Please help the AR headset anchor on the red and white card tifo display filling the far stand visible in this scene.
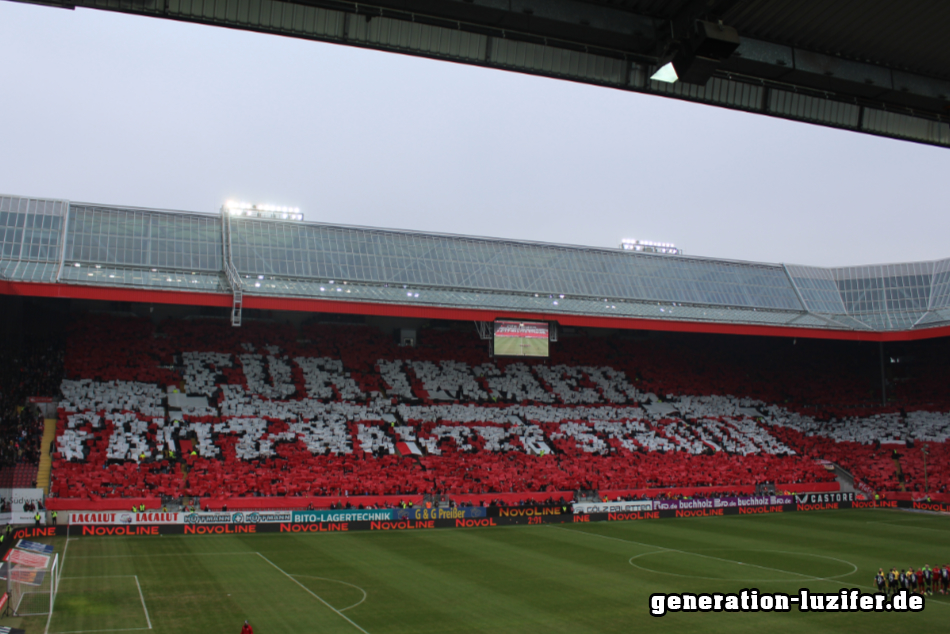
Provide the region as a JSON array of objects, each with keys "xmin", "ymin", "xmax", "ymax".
[{"xmin": 44, "ymin": 315, "xmax": 950, "ymax": 505}]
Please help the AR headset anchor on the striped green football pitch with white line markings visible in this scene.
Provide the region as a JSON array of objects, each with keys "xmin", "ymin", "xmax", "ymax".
[{"xmin": 7, "ymin": 510, "xmax": 950, "ymax": 634}]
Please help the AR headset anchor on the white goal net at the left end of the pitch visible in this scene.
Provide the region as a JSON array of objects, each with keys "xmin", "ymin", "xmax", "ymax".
[{"xmin": 0, "ymin": 548, "xmax": 60, "ymax": 616}]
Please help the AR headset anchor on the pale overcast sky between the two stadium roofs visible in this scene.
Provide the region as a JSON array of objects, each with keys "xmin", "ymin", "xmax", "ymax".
[{"xmin": 0, "ymin": 1, "xmax": 950, "ymax": 266}]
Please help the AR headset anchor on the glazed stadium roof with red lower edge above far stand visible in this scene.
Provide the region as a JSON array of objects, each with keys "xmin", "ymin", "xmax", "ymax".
[{"xmin": 0, "ymin": 196, "xmax": 950, "ymax": 340}]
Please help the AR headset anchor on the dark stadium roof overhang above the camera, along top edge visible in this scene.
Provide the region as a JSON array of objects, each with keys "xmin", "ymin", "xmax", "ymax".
[{"xmin": 13, "ymin": 0, "xmax": 950, "ymax": 147}]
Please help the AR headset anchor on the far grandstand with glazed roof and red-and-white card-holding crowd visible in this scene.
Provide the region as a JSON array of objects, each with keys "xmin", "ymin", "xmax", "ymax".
[{"xmin": 0, "ymin": 189, "xmax": 950, "ymax": 510}]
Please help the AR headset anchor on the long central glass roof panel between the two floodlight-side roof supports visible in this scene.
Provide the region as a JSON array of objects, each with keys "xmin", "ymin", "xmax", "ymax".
[{"xmin": 231, "ymin": 218, "xmax": 802, "ymax": 310}]
